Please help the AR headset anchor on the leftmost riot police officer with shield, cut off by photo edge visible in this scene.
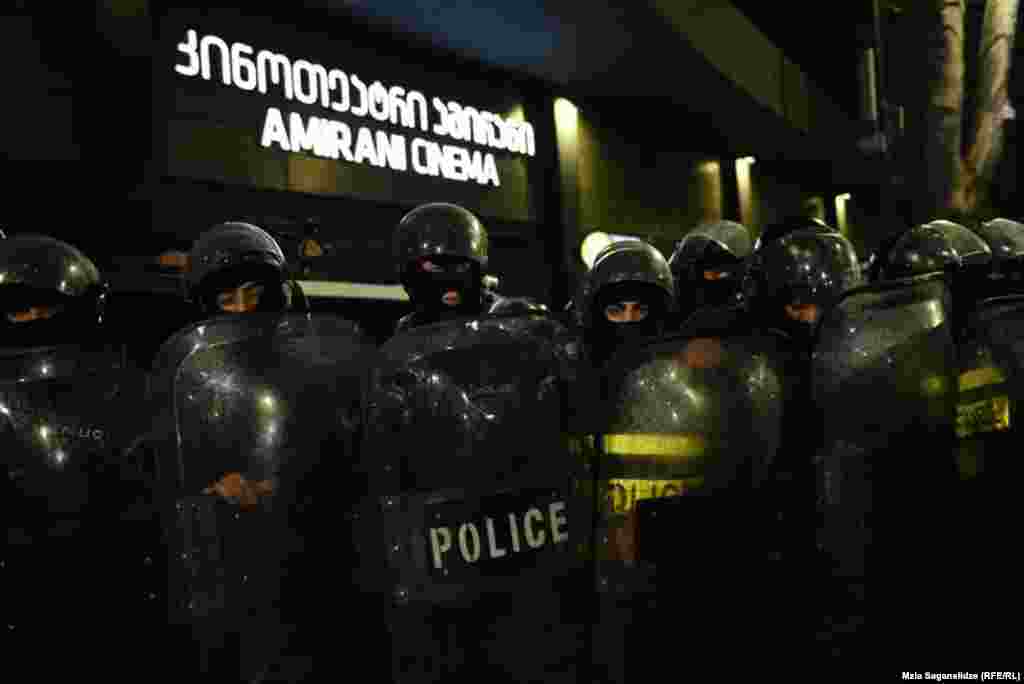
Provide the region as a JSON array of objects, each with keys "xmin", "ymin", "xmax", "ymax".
[{"xmin": 0, "ymin": 234, "xmax": 159, "ymax": 679}]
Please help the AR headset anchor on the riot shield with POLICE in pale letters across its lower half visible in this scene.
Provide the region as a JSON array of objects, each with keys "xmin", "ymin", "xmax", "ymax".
[{"xmin": 360, "ymin": 314, "xmax": 588, "ymax": 682}]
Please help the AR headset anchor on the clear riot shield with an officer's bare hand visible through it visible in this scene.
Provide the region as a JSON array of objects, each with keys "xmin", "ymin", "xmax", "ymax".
[{"xmin": 151, "ymin": 314, "xmax": 373, "ymax": 681}]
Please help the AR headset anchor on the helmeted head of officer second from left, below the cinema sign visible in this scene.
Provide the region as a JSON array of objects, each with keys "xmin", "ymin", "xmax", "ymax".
[{"xmin": 185, "ymin": 221, "xmax": 289, "ymax": 316}]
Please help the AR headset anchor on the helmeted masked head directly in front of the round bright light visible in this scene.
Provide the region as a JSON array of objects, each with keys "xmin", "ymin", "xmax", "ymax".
[{"xmin": 580, "ymin": 240, "xmax": 676, "ymax": 361}]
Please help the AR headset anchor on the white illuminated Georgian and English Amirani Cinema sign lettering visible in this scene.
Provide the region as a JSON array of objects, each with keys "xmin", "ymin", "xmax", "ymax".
[{"xmin": 174, "ymin": 29, "xmax": 536, "ymax": 187}]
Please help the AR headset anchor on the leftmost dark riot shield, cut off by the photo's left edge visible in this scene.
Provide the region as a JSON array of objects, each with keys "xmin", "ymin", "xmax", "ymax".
[{"xmin": 0, "ymin": 344, "xmax": 153, "ymax": 678}]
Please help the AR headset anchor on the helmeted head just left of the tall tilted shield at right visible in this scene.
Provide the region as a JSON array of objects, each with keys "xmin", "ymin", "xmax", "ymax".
[{"xmin": 744, "ymin": 230, "xmax": 862, "ymax": 340}]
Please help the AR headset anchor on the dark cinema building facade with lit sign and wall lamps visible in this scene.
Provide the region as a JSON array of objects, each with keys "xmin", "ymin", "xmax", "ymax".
[{"xmin": 5, "ymin": 0, "xmax": 876, "ymax": 307}]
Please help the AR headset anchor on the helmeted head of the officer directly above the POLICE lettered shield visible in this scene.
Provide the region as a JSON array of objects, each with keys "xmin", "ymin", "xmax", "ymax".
[{"xmin": 394, "ymin": 203, "xmax": 487, "ymax": 315}]
